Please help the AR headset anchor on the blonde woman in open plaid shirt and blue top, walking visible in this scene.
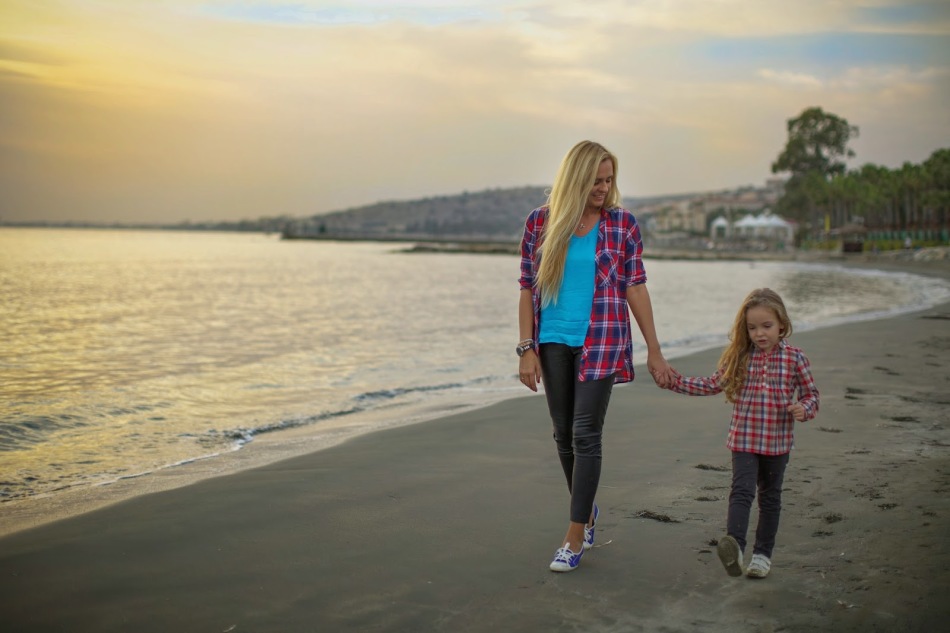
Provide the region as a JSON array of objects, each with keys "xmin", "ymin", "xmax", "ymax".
[{"xmin": 517, "ymin": 141, "xmax": 673, "ymax": 572}]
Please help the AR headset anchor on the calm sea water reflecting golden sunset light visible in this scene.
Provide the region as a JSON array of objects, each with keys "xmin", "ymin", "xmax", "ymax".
[{"xmin": 0, "ymin": 229, "xmax": 950, "ymax": 501}]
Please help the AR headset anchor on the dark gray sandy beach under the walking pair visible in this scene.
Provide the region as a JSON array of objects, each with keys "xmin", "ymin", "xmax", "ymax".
[{"xmin": 0, "ymin": 264, "xmax": 950, "ymax": 633}]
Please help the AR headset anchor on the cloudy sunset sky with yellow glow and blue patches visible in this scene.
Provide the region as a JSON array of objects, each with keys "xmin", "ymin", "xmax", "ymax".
[{"xmin": 0, "ymin": 0, "xmax": 950, "ymax": 223}]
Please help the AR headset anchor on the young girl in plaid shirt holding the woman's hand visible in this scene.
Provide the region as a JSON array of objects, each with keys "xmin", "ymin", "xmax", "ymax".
[{"xmin": 670, "ymin": 288, "xmax": 818, "ymax": 578}]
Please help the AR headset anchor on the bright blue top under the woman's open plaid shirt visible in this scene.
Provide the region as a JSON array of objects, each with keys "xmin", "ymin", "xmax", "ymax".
[{"xmin": 538, "ymin": 226, "xmax": 599, "ymax": 347}]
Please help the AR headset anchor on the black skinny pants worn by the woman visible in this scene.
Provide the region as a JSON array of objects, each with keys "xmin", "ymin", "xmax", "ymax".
[{"xmin": 540, "ymin": 343, "xmax": 614, "ymax": 524}]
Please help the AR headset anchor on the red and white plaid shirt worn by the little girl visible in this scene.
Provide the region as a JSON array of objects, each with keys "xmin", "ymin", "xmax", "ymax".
[{"xmin": 671, "ymin": 340, "xmax": 818, "ymax": 455}]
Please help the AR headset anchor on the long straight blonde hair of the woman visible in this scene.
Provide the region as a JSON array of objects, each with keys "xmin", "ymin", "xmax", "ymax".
[{"xmin": 535, "ymin": 141, "xmax": 621, "ymax": 305}]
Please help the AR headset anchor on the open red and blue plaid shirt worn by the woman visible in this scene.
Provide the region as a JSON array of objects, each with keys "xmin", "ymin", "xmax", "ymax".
[{"xmin": 519, "ymin": 207, "xmax": 647, "ymax": 383}]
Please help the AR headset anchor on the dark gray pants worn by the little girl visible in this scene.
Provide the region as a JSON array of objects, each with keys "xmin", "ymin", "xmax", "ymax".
[{"xmin": 726, "ymin": 451, "xmax": 789, "ymax": 559}]
